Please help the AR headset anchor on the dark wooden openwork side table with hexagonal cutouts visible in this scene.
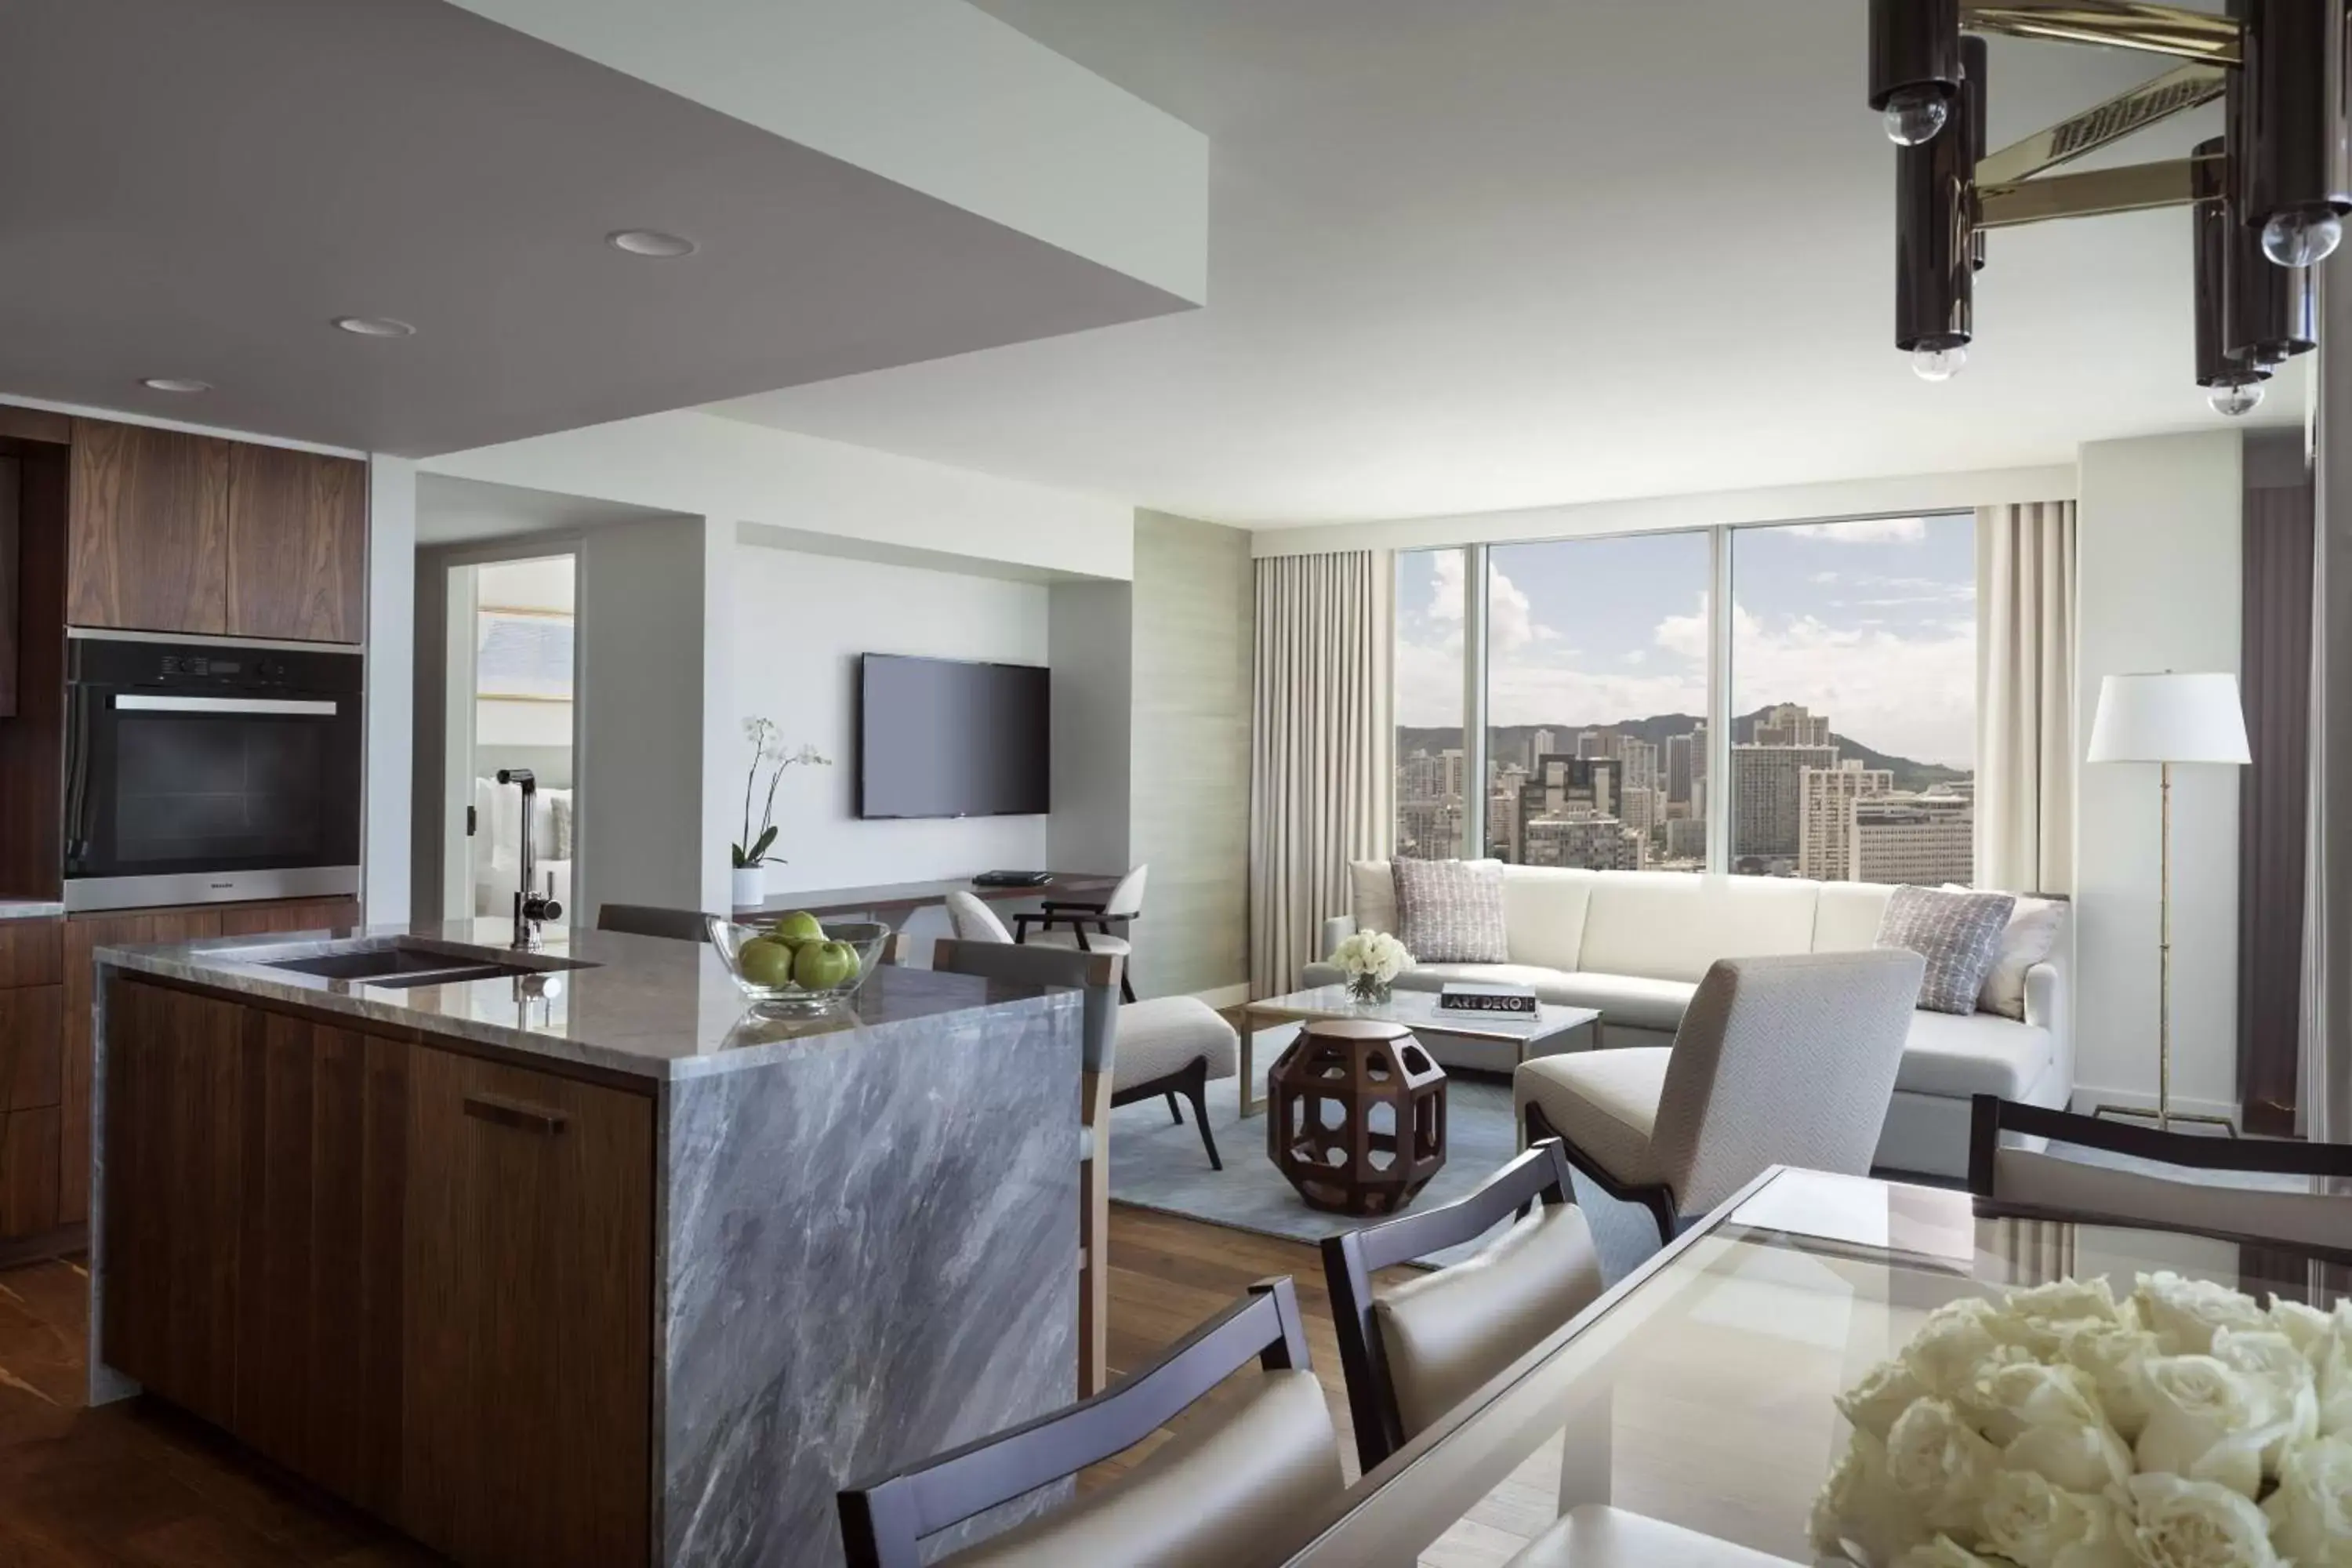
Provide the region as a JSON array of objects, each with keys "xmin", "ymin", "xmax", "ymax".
[{"xmin": 1265, "ymin": 1018, "xmax": 1446, "ymax": 1218}]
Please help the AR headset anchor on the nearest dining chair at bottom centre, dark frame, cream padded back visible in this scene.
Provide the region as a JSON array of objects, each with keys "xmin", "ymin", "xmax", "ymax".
[{"xmin": 840, "ymin": 1279, "xmax": 1345, "ymax": 1568}]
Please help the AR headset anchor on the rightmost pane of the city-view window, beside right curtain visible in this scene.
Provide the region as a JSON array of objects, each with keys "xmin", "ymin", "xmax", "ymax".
[{"xmin": 1729, "ymin": 515, "xmax": 1976, "ymax": 886}]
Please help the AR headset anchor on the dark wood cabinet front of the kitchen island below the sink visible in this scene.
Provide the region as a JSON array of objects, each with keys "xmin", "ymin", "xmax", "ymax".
[{"xmin": 101, "ymin": 975, "xmax": 654, "ymax": 1566}]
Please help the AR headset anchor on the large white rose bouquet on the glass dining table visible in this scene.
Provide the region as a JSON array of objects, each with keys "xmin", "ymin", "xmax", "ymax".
[{"xmin": 1811, "ymin": 1272, "xmax": 2352, "ymax": 1568}]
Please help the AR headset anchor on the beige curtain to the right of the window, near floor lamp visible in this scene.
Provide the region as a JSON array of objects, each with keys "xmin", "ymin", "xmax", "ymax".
[{"xmin": 1976, "ymin": 501, "xmax": 2074, "ymax": 893}]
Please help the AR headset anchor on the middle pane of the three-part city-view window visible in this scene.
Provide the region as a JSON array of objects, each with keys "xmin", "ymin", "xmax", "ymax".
[{"xmin": 1484, "ymin": 534, "xmax": 1710, "ymax": 869}]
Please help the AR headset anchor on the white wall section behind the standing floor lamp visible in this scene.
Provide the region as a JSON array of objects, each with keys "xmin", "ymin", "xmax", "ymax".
[{"xmin": 2074, "ymin": 430, "xmax": 2244, "ymax": 1112}]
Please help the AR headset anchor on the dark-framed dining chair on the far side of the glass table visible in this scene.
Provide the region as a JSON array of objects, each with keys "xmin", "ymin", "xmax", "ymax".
[{"xmin": 1969, "ymin": 1095, "xmax": 2352, "ymax": 1253}]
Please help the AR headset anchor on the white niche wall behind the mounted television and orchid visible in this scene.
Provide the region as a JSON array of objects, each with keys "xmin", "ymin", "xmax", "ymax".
[{"xmin": 729, "ymin": 543, "xmax": 1054, "ymax": 907}]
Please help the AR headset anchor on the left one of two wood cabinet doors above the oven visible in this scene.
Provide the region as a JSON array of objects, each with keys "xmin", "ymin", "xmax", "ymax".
[{"xmin": 66, "ymin": 419, "xmax": 233, "ymax": 635}]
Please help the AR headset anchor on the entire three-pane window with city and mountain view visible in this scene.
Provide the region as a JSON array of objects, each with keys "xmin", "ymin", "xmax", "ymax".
[{"xmin": 1395, "ymin": 513, "xmax": 1976, "ymax": 884}]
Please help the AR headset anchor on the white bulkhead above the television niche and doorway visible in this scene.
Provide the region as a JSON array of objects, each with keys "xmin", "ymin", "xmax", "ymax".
[{"xmin": 423, "ymin": 409, "xmax": 1134, "ymax": 579}]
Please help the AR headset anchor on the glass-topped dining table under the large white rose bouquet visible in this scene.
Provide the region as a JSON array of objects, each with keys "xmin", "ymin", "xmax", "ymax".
[{"xmin": 1291, "ymin": 1168, "xmax": 2343, "ymax": 1568}]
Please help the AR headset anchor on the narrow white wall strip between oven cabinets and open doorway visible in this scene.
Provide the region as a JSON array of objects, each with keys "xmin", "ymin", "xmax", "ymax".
[{"xmin": 360, "ymin": 456, "xmax": 416, "ymax": 926}]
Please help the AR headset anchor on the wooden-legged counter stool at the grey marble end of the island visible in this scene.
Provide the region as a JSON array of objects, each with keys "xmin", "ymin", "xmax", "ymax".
[{"xmin": 931, "ymin": 938, "xmax": 1120, "ymax": 1394}]
